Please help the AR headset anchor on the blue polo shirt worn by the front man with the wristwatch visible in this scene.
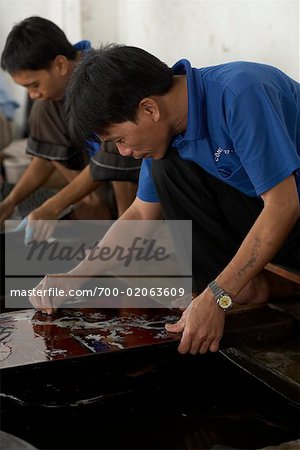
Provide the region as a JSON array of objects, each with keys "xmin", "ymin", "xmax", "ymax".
[{"xmin": 137, "ymin": 59, "xmax": 300, "ymax": 202}]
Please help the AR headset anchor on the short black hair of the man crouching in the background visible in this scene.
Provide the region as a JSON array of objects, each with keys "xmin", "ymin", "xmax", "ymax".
[{"xmin": 1, "ymin": 16, "xmax": 76, "ymax": 75}]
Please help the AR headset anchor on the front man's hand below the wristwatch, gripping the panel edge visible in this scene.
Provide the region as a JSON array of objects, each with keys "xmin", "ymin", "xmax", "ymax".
[{"xmin": 166, "ymin": 288, "xmax": 225, "ymax": 355}]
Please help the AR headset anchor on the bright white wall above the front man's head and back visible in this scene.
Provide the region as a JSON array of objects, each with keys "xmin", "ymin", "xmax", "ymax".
[{"xmin": 81, "ymin": 0, "xmax": 299, "ymax": 79}]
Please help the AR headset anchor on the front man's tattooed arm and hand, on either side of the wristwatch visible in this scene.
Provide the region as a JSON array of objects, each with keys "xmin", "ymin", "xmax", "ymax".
[{"xmin": 167, "ymin": 175, "xmax": 299, "ymax": 354}]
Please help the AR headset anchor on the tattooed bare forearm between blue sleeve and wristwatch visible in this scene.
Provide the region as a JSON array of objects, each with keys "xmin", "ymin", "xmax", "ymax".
[{"xmin": 217, "ymin": 175, "xmax": 300, "ymax": 297}]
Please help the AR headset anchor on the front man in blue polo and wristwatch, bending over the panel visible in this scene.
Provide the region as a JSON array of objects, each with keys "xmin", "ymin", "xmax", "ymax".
[{"xmin": 32, "ymin": 45, "xmax": 300, "ymax": 354}]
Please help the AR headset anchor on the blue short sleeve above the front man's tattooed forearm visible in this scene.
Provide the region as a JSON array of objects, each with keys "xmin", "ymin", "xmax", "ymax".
[{"xmin": 227, "ymin": 84, "xmax": 300, "ymax": 195}]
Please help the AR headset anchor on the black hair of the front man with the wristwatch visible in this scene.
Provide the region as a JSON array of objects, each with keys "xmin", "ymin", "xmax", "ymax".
[{"xmin": 65, "ymin": 44, "xmax": 173, "ymax": 145}]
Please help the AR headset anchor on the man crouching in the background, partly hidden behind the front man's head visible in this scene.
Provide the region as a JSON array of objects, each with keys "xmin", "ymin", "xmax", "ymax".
[{"xmin": 0, "ymin": 17, "xmax": 139, "ymax": 238}]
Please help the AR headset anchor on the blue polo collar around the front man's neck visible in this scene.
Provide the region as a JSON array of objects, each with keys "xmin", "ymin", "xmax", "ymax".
[{"xmin": 172, "ymin": 59, "xmax": 205, "ymax": 141}]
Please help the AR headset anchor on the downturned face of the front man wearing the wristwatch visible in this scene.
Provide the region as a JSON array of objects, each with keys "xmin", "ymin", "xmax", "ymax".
[{"xmin": 100, "ymin": 107, "xmax": 172, "ymax": 159}]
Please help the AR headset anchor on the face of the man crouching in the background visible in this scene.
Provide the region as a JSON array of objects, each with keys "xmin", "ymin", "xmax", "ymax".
[{"xmin": 12, "ymin": 60, "xmax": 66, "ymax": 100}]
